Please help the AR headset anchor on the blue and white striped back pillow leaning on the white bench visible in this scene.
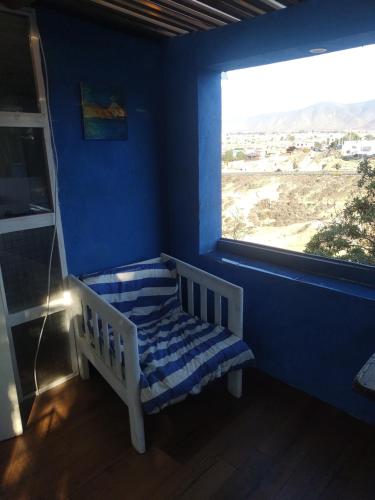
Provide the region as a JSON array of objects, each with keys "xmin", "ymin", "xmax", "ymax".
[{"xmin": 81, "ymin": 257, "xmax": 181, "ymax": 326}]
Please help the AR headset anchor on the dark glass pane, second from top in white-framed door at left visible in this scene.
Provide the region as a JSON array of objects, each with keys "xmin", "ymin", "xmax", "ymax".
[{"xmin": 0, "ymin": 127, "xmax": 52, "ymax": 219}]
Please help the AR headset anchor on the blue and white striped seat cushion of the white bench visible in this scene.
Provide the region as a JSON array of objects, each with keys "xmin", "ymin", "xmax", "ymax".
[{"xmin": 138, "ymin": 312, "xmax": 254, "ymax": 413}]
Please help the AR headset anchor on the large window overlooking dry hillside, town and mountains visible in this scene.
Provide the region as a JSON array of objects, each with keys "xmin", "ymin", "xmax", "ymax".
[{"xmin": 222, "ymin": 45, "xmax": 375, "ymax": 264}]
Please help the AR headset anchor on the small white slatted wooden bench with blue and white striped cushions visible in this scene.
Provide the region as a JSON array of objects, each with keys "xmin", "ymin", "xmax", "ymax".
[{"xmin": 69, "ymin": 254, "xmax": 254, "ymax": 453}]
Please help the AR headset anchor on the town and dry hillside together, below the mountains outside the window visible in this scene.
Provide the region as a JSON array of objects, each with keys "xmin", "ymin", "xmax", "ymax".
[{"xmin": 222, "ymin": 130, "xmax": 375, "ymax": 252}]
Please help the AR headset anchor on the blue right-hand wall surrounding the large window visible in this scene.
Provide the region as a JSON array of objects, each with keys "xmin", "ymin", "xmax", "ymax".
[{"xmin": 165, "ymin": 0, "xmax": 375, "ymax": 423}]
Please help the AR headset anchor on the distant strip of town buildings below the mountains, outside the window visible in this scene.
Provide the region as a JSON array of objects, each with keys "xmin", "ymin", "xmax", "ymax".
[{"xmin": 222, "ymin": 130, "xmax": 375, "ymax": 173}]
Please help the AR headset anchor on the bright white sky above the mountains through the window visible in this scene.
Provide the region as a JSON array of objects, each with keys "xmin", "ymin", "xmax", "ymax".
[{"xmin": 221, "ymin": 45, "xmax": 375, "ymax": 131}]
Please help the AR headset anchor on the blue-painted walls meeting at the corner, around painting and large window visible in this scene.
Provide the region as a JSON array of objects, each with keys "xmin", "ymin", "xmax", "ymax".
[{"xmin": 38, "ymin": 0, "xmax": 375, "ymax": 422}]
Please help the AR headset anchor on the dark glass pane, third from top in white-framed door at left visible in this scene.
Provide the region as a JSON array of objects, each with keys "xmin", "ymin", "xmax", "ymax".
[{"xmin": 0, "ymin": 226, "xmax": 62, "ymax": 313}]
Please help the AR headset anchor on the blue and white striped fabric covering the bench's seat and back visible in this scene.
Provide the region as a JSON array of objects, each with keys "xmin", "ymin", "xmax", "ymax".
[{"xmin": 83, "ymin": 259, "xmax": 254, "ymax": 413}]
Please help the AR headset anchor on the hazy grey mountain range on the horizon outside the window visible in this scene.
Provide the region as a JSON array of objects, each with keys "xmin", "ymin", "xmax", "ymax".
[{"xmin": 230, "ymin": 100, "xmax": 375, "ymax": 133}]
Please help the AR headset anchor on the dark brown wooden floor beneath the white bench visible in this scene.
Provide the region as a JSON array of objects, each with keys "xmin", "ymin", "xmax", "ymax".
[{"xmin": 0, "ymin": 372, "xmax": 375, "ymax": 500}]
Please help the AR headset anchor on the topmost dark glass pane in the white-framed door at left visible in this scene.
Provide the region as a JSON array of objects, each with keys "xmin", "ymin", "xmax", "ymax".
[{"xmin": 0, "ymin": 12, "xmax": 39, "ymax": 113}]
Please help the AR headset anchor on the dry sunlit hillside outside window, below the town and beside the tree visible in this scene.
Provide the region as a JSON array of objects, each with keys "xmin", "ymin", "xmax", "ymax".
[{"xmin": 222, "ymin": 173, "xmax": 359, "ymax": 252}]
